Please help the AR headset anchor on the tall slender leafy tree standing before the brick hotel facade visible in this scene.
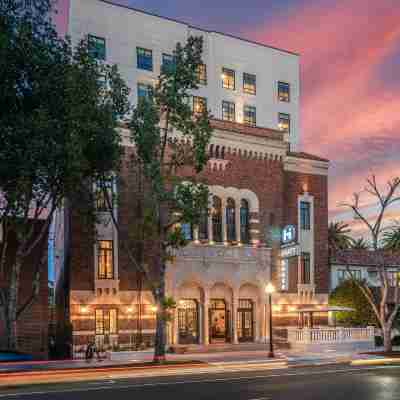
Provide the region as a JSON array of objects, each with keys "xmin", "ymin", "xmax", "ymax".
[{"xmin": 104, "ymin": 37, "xmax": 212, "ymax": 362}]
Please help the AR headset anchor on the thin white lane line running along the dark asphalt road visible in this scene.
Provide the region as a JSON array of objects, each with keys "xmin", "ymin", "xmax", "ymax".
[{"xmin": 0, "ymin": 365, "xmax": 400, "ymax": 398}]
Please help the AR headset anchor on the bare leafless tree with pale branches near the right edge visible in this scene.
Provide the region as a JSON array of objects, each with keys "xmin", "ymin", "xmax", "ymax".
[{"xmin": 343, "ymin": 175, "xmax": 400, "ymax": 352}]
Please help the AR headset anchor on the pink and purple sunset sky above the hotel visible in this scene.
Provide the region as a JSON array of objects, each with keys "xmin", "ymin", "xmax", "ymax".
[{"xmin": 57, "ymin": 0, "xmax": 400, "ymax": 219}]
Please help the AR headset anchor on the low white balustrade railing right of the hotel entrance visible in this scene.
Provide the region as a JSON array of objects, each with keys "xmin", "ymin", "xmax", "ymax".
[{"xmin": 288, "ymin": 326, "xmax": 375, "ymax": 343}]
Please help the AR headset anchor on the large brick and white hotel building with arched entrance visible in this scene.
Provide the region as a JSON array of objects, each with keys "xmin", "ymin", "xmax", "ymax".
[{"xmin": 55, "ymin": 0, "xmax": 329, "ymax": 350}]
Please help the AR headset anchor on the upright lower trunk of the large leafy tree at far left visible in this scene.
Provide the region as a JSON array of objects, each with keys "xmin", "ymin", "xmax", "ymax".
[{"xmin": 5, "ymin": 252, "xmax": 22, "ymax": 350}]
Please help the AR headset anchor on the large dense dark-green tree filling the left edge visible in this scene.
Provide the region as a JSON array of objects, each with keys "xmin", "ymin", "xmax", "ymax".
[{"xmin": 0, "ymin": 0, "xmax": 128, "ymax": 349}]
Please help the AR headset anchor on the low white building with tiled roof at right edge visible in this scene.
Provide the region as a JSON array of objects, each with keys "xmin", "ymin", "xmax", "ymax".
[{"xmin": 330, "ymin": 249, "xmax": 400, "ymax": 291}]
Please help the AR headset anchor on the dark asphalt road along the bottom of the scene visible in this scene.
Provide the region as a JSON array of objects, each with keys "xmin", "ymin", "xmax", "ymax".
[{"xmin": 0, "ymin": 365, "xmax": 400, "ymax": 400}]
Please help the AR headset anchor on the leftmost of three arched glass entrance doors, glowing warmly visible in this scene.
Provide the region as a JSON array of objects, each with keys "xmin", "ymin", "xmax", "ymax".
[{"xmin": 178, "ymin": 300, "xmax": 199, "ymax": 344}]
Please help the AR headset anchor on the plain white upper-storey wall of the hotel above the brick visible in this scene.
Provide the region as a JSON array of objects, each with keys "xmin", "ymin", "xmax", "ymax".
[{"xmin": 68, "ymin": 0, "xmax": 300, "ymax": 150}]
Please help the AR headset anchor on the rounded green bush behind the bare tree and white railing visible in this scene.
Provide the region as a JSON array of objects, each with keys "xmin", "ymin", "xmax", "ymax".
[{"xmin": 329, "ymin": 279, "xmax": 378, "ymax": 326}]
